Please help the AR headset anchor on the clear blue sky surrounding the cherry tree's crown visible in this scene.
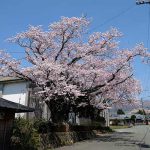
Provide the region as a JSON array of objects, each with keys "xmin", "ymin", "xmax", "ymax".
[{"xmin": 0, "ymin": 0, "xmax": 150, "ymax": 99}]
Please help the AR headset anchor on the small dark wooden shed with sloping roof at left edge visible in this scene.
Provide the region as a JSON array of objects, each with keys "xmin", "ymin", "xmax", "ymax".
[{"xmin": 0, "ymin": 98, "xmax": 34, "ymax": 150}]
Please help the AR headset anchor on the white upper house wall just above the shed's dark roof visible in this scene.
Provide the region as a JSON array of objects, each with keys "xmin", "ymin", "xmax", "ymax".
[{"xmin": 2, "ymin": 82, "xmax": 27, "ymax": 105}]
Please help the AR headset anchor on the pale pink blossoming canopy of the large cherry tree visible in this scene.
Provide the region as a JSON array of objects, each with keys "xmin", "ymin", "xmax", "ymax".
[{"xmin": 0, "ymin": 17, "xmax": 149, "ymax": 122}]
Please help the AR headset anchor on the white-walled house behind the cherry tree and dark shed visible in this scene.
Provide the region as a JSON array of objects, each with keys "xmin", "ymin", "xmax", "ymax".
[{"xmin": 0, "ymin": 77, "xmax": 50, "ymax": 119}]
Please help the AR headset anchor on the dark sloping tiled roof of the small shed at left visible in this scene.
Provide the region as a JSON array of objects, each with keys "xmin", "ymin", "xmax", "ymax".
[{"xmin": 0, "ymin": 98, "xmax": 34, "ymax": 113}]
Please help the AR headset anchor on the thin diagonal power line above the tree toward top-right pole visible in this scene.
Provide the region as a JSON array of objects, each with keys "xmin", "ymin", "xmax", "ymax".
[{"xmin": 89, "ymin": 5, "xmax": 135, "ymax": 32}]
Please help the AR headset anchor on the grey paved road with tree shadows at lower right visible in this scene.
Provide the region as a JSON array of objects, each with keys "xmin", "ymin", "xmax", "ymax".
[{"xmin": 55, "ymin": 125, "xmax": 150, "ymax": 150}]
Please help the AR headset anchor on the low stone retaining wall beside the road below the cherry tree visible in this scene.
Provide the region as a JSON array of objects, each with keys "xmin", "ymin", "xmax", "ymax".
[{"xmin": 39, "ymin": 131, "xmax": 96, "ymax": 150}]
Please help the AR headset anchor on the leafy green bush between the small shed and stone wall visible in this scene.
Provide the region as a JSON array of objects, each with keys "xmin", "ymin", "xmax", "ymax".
[{"xmin": 11, "ymin": 118, "xmax": 39, "ymax": 150}]
